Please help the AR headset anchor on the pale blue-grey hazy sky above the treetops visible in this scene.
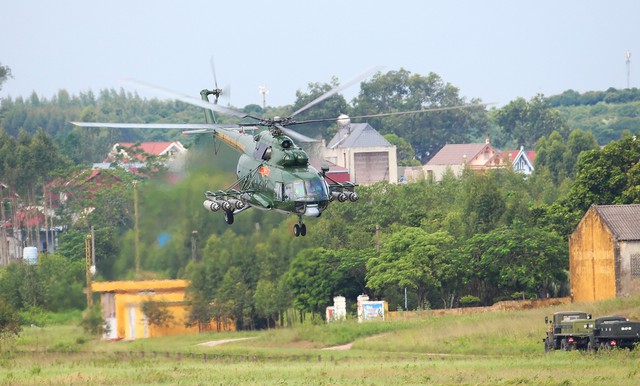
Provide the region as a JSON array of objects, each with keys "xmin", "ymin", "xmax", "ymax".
[{"xmin": 0, "ymin": 0, "xmax": 640, "ymax": 107}]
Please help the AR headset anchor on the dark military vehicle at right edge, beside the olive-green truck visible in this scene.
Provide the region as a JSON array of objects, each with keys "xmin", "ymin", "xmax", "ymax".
[{"xmin": 588, "ymin": 316, "xmax": 640, "ymax": 351}]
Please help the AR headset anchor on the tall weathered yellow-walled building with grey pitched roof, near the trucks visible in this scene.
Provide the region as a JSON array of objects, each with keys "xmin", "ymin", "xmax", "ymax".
[{"xmin": 569, "ymin": 204, "xmax": 640, "ymax": 301}]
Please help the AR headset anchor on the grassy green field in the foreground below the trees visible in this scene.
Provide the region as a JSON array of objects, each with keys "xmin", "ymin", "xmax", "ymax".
[{"xmin": 0, "ymin": 297, "xmax": 640, "ymax": 385}]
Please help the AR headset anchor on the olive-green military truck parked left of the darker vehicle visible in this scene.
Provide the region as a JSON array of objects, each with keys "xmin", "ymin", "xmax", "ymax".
[{"xmin": 542, "ymin": 311, "xmax": 593, "ymax": 351}]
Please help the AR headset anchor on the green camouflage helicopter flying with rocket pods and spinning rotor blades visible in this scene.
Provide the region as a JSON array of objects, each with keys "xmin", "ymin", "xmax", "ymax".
[{"xmin": 71, "ymin": 67, "xmax": 484, "ymax": 237}]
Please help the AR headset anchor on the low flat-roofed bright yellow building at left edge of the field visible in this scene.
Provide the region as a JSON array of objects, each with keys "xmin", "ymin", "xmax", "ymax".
[{"xmin": 91, "ymin": 280, "xmax": 235, "ymax": 340}]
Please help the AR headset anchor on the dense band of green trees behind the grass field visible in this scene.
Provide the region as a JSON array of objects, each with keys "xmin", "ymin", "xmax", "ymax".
[{"xmin": 0, "ymin": 64, "xmax": 640, "ymax": 329}]
